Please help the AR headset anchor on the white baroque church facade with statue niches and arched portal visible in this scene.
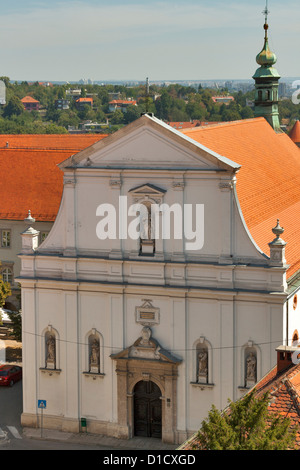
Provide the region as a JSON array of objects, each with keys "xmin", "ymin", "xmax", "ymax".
[{"xmin": 18, "ymin": 114, "xmax": 300, "ymax": 443}]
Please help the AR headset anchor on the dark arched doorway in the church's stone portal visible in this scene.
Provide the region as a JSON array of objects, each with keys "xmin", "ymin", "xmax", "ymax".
[{"xmin": 134, "ymin": 380, "xmax": 162, "ymax": 438}]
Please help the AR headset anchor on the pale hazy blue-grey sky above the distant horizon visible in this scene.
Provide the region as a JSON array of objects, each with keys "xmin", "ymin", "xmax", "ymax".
[{"xmin": 0, "ymin": 0, "xmax": 300, "ymax": 83}]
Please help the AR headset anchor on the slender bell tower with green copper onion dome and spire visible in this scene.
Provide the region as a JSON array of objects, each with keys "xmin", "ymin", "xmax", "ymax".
[{"xmin": 253, "ymin": 2, "xmax": 282, "ymax": 132}]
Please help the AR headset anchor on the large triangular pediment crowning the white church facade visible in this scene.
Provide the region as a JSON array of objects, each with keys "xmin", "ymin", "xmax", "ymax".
[{"xmin": 60, "ymin": 115, "xmax": 239, "ymax": 171}]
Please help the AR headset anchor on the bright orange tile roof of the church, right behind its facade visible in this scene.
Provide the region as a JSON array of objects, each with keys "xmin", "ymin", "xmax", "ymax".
[{"xmin": 182, "ymin": 118, "xmax": 300, "ymax": 277}]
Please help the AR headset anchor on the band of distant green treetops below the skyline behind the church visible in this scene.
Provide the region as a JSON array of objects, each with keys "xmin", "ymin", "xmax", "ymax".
[{"xmin": 0, "ymin": 77, "xmax": 300, "ymax": 134}]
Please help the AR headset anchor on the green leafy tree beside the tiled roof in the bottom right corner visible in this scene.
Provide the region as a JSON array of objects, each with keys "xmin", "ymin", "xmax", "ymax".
[{"xmin": 198, "ymin": 389, "xmax": 296, "ymax": 450}]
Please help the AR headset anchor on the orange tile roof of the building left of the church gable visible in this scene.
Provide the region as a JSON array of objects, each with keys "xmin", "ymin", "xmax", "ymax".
[{"xmin": 0, "ymin": 134, "xmax": 105, "ymax": 222}]
